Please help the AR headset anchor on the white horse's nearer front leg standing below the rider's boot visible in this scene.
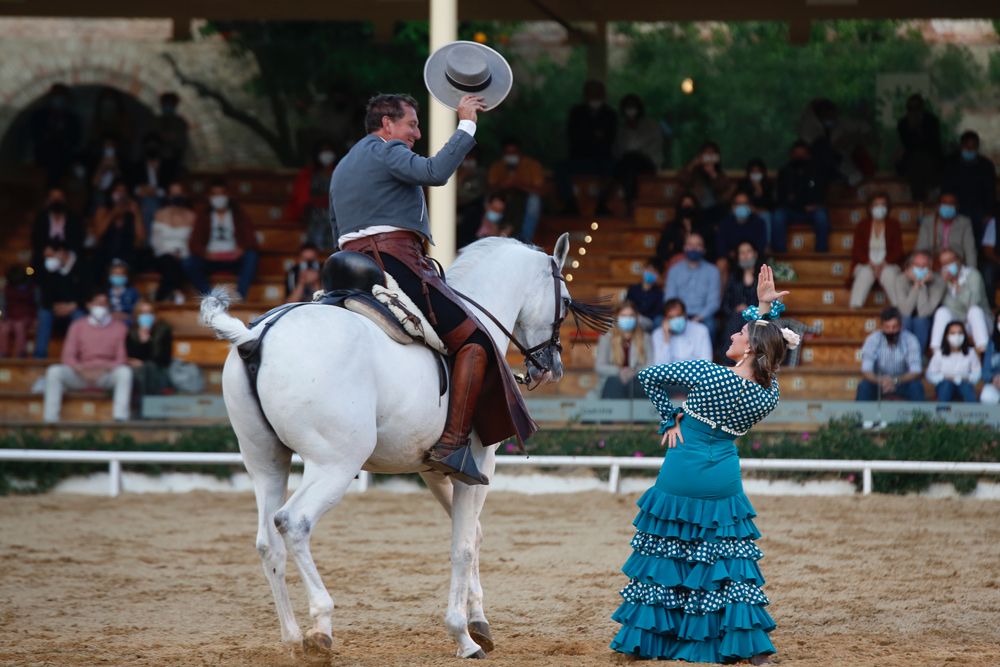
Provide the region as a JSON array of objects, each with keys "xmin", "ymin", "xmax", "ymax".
[{"xmin": 445, "ymin": 442, "xmax": 494, "ymax": 658}]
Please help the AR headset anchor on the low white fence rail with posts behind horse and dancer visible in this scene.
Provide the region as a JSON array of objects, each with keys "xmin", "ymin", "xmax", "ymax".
[{"xmin": 0, "ymin": 449, "xmax": 1000, "ymax": 497}]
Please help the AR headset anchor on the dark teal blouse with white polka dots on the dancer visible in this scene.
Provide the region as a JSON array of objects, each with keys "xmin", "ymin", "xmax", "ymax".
[{"xmin": 637, "ymin": 359, "xmax": 779, "ymax": 435}]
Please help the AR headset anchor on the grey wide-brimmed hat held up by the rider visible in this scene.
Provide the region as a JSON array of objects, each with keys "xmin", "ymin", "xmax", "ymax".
[{"xmin": 424, "ymin": 41, "xmax": 514, "ymax": 109}]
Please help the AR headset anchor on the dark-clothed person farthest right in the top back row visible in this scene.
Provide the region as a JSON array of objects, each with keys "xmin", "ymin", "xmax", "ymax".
[{"xmin": 896, "ymin": 93, "xmax": 944, "ymax": 202}]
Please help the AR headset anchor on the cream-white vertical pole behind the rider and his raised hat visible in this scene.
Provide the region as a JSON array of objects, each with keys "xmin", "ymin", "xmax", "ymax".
[{"xmin": 427, "ymin": 0, "xmax": 458, "ymax": 267}]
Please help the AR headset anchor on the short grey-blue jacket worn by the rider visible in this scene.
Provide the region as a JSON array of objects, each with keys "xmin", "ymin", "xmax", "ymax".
[{"xmin": 330, "ymin": 130, "xmax": 476, "ymax": 243}]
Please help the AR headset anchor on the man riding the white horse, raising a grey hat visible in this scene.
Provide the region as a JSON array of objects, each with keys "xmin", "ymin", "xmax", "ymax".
[{"xmin": 330, "ymin": 42, "xmax": 537, "ymax": 484}]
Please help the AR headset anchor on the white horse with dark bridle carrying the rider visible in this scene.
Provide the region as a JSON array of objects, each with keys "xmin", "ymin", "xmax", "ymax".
[{"xmin": 201, "ymin": 234, "xmax": 576, "ymax": 658}]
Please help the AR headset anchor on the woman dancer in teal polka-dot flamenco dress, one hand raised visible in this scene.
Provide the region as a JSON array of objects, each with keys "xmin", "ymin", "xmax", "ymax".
[{"xmin": 611, "ymin": 265, "xmax": 799, "ymax": 665}]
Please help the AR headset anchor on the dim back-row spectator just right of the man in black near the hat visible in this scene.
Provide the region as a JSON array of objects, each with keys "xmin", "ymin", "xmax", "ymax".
[{"xmin": 615, "ymin": 93, "xmax": 663, "ymax": 218}]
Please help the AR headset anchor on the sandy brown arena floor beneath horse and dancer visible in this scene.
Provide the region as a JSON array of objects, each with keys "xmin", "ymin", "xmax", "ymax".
[{"xmin": 0, "ymin": 491, "xmax": 1000, "ymax": 667}]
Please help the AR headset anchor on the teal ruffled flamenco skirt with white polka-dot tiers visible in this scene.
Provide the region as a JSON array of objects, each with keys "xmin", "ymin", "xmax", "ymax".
[{"xmin": 611, "ymin": 416, "xmax": 775, "ymax": 663}]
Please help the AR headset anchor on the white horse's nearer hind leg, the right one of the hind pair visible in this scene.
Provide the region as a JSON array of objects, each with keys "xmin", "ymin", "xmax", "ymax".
[{"xmin": 274, "ymin": 457, "xmax": 364, "ymax": 655}]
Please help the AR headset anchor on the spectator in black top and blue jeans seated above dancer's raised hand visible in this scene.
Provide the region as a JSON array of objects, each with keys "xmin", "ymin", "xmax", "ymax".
[{"xmin": 771, "ymin": 141, "xmax": 830, "ymax": 253}]
